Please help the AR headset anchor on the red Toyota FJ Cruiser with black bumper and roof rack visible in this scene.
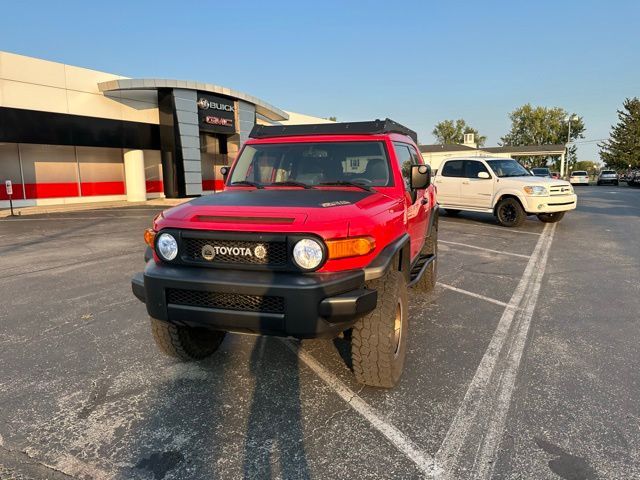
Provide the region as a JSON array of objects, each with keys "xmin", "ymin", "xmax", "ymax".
[{"xmin": 132, "ymin": 119, "xmax": 438, "ymax": 387}]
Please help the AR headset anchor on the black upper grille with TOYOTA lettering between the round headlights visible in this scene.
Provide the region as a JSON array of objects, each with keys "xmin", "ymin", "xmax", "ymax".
[{"xmin": 182, "ymin": 238, "xmax": 287, "ymax": 266}]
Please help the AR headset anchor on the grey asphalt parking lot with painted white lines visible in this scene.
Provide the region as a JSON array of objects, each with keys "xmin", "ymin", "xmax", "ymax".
[{"xmin": 0, "ymin": 186, "xmax": 640, "ymax": 479}]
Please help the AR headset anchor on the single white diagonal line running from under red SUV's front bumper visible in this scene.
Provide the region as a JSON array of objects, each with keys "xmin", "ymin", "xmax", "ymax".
[{"xmin": 282, "ymin": 340, "xmax": 440, "ymax": 478}]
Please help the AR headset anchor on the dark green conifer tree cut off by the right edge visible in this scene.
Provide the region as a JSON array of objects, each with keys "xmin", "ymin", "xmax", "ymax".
[{"xmin": 598, "ymin": 97, "xmax": 640, "ymax": 170}]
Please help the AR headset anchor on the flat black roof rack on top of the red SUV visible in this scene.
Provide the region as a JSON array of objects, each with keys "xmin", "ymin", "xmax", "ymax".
[{"xmin": 249, "ymin": 118, "xmax": 418, "ymax": 143}]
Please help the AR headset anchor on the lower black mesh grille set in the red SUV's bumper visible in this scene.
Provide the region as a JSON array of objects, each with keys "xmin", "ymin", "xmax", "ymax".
[{"xmin": 167, "ymin": 288, "xmax": 284, "ymax": 313}]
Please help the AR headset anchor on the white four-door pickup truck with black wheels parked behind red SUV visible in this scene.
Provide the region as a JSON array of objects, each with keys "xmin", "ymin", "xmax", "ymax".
[{"xmin": 434, "ymin": 157, "xmax": 577, "ymax": 227}]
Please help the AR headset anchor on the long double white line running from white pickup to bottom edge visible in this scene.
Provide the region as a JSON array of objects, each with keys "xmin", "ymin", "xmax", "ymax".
[{"xmin": 435, "ymin": 223, "xmax": 557, "ymax": 479}]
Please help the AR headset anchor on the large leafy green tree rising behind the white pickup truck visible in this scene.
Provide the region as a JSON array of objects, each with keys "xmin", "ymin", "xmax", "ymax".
[{"xmin": 501, "ymin": 103, "xmax": 585, "ymax": 169}]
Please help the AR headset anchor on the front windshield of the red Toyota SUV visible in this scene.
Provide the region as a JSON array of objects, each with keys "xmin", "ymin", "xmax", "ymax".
[{"xmin": 227, "ymin": 142, "xmax": 392, "ymax": 187}]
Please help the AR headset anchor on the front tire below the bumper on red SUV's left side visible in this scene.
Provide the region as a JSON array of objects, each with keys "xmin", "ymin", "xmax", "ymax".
[{"xmin": 151, "ymin": 318, "xmax": 226, "ymax": 362}]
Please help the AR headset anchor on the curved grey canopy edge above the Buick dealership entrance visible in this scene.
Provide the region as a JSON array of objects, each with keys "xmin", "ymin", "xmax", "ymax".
[{"xmin": 98, "ymin": 78, "xmax": 289, "ymax": 121}]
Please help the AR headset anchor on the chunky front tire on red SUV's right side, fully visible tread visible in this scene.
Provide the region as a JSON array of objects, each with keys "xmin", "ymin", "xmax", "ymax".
[{"xmin": 351, "ymin": 270, "xmax": 409, "ymax": 388}]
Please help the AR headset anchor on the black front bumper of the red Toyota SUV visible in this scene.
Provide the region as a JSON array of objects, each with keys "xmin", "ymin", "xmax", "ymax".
[{"xmin": 131, "ymin": 260, "xmax": 377, "ymax": 338}]
